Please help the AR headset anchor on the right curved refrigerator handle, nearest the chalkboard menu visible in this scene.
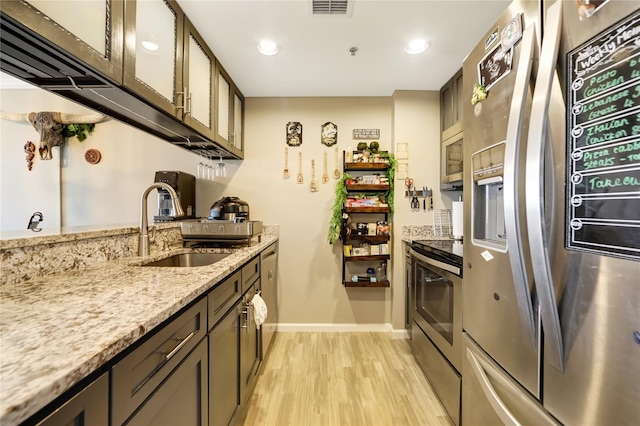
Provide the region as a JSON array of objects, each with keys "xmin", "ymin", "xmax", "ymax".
[{"xmin": 525, "ymin": 1, "xmax": 564, "ymax": 371}]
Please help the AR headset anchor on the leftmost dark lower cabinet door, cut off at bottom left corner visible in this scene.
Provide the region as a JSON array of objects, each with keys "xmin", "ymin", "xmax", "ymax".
[{"xmin": 38, "ymin": 373, "xmax": 109, "ymax": 426}]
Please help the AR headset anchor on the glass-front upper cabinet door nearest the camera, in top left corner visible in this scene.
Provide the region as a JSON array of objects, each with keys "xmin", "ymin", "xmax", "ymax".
[{"xmin": 0, "ymin": 0, "xmax": 124, "ymax": 84}]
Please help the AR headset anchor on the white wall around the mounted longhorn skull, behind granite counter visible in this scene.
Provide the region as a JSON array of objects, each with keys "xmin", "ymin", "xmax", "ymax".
[{"xmin": 0, "ymin": 89, "xmax": 225, "ymax": 231}]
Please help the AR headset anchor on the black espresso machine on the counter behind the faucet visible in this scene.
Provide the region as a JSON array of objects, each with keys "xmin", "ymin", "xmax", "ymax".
[{"xmin": 153, "ymin": 171, "xmax": 196, "ymax": 222}]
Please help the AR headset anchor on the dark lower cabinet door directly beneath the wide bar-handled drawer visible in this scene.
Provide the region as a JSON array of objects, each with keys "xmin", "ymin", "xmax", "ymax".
[{"xmin": 127, "ymin": 339, "xmax": 209, "ymax": 426}]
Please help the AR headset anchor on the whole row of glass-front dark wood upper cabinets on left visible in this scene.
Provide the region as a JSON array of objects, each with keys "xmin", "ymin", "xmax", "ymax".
[{"xmin": 0, "ymin": 0, "xmax": 244, "ymax": 159}]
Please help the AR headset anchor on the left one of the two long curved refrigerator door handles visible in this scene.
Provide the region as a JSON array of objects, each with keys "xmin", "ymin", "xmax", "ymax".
[{"xmin": 503, "ymin": 21, "xmax": 538, "ymax": 349}]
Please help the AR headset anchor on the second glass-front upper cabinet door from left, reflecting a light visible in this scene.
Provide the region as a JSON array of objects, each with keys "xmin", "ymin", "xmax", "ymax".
[{"xmin": 124, "ymin": 0, "xmax": 186, "ymax": 119}]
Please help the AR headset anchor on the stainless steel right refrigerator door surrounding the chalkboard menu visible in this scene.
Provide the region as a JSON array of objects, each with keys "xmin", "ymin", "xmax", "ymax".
[{"xmin": 536, "ymin": 0, "xmax": 640, "ymax": 425}]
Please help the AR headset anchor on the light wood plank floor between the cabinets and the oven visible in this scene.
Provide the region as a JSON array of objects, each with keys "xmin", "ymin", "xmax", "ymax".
[{"xmin": 239, "ymin": 332, "xmax": 452, "ymax": 426}]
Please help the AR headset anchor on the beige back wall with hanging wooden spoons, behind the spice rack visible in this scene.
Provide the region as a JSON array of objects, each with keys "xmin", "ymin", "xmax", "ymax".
[{"xmin": 239, "ymin": 98, "xmax": 392, "ymax": 323}]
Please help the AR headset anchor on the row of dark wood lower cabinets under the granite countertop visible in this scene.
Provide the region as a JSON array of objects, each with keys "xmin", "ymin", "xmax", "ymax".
[{"xmin": 27, "ymin": 250, "xmax": 277, "ymax": 426}]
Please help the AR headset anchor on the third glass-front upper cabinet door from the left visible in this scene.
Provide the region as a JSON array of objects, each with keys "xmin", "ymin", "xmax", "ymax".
[{"xmin": 183, "ymin": 18, "xmax": 215, "ymax": 140}]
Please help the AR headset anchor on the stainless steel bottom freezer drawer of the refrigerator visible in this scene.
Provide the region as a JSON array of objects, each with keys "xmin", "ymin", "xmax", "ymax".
[{"xmin": 462, "ymin": 334, "xmax": 559, "ymax": 426}]
